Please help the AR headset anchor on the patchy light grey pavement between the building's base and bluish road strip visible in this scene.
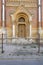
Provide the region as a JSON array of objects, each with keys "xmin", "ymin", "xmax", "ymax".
[{"xmin": 0, "ymin": 44, "xmax": 43, "ymax": 59}]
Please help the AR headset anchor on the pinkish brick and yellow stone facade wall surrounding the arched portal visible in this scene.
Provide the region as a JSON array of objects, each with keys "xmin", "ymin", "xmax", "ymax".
[{"xmin": 0, "ymin": 0, "xmax": 43, "ymax": 37}]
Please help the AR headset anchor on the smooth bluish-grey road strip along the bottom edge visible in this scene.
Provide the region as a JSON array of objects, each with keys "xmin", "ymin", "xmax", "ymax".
[{"xmin": 0, "ymin": 59, "xmax": 43, "ymax": 65}]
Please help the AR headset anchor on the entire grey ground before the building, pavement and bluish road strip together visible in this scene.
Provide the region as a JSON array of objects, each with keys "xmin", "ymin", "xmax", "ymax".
[{"xmin": 0, "ymin": 44, "xmax": 43, "ymax": 65}]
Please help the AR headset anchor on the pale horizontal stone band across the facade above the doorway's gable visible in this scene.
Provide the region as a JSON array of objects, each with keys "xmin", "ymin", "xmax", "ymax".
[{"xmin": 6, "ymin": 2, "xmax": 37, "ymax": 7}]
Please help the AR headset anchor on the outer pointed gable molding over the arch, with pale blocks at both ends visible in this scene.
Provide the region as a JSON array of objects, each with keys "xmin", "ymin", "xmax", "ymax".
[{"xmin": 10, "ymin": 5, "xmax": 32, "ymax": 22}]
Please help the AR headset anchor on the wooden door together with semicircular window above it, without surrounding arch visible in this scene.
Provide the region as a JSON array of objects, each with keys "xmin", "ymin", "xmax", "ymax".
[{"xmin": 18, "ymin": 16, "xmax": 26, "ymax": 38}]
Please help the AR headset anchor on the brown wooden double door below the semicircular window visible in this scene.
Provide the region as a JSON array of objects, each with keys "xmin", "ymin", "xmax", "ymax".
[{"xmin": 18, "ymin": 24, "xmax": 26, "ymax": 38}]
